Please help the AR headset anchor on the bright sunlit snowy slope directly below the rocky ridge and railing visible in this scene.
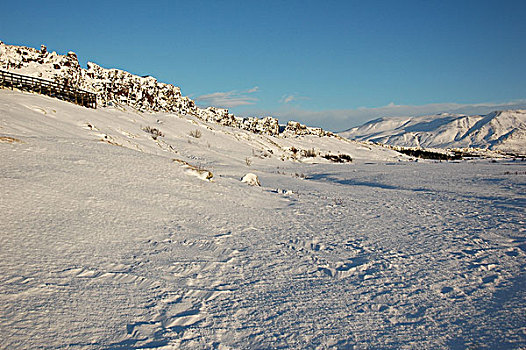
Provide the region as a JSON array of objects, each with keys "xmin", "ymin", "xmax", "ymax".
[{"xmin": 0, "ymin": 90, "xmax": 405, "ymax": 169}]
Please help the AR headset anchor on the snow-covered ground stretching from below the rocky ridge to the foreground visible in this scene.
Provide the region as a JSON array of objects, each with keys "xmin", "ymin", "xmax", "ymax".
[{"xmin": 0, "ymin": 90, "xmax": 526, "ymax": 349}]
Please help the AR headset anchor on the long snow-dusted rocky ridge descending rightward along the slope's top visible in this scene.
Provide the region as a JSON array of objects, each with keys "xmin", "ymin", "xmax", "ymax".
[{"xmin": 0, "ymin": 41, "xmax": 335, "ymax": 137}]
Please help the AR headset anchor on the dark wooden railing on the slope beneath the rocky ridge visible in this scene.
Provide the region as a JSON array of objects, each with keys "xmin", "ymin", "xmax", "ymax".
[{"xmin": 0, "ymin": 70, "xmax": 97, "ymax": 108}]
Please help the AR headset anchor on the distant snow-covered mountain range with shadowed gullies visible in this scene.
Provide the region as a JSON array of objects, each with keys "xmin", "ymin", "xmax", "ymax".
[{"xmin": 339, "ymin": 110, "xmax": 526, "ymax": 154}]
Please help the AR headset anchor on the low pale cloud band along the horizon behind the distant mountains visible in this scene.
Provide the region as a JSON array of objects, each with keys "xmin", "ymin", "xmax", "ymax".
[{"xmin": 266, "ymin": 99, "xmax": 526, "ymax": 131}]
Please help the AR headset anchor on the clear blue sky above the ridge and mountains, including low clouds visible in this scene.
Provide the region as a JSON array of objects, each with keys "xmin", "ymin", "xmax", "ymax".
[{"xmin": 0, "ymin": 0, "xmax": 526, "ymax": 130}]
